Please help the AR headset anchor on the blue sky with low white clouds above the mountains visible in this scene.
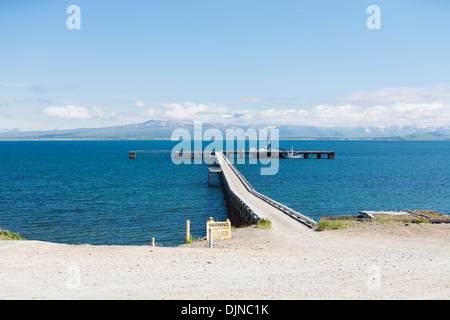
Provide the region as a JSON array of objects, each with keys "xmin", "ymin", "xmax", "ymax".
[{"xmin": 0, "ymin": 0, "xmax": 450, "ymax": 131}]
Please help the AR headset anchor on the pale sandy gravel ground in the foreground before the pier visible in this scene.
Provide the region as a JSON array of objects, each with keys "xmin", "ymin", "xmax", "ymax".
[{"xmin": 0, "ymin": 219, "xmax": 450, "ymax": 300}]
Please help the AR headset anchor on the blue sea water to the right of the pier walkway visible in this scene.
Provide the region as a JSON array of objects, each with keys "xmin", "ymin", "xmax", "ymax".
[{"xmin": 236, "ymin": 141, "xmax": 450, "ymax": 221}]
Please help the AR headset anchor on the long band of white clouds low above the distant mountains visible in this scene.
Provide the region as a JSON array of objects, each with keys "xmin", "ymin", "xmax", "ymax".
[{"xmin": 42, "ymin": 84, "xmax": 450, "ymax": 126}]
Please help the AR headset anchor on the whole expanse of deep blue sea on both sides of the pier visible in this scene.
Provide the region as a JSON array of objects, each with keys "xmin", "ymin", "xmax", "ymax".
[{"xmin": 0, "ymin": 140, "xmax": 450, "ymax": 245}]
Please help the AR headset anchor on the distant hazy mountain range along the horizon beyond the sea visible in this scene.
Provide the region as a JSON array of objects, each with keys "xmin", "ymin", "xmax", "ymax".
[{"xmin": 0, "ymin": 120, "xmax": 450, "ymax": 140}]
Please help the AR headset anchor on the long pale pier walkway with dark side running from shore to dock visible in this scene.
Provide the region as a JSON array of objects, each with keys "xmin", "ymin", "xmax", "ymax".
[{"xmin": 210, "ymin": 152, "xmax": 316, "ymax": 228}]
